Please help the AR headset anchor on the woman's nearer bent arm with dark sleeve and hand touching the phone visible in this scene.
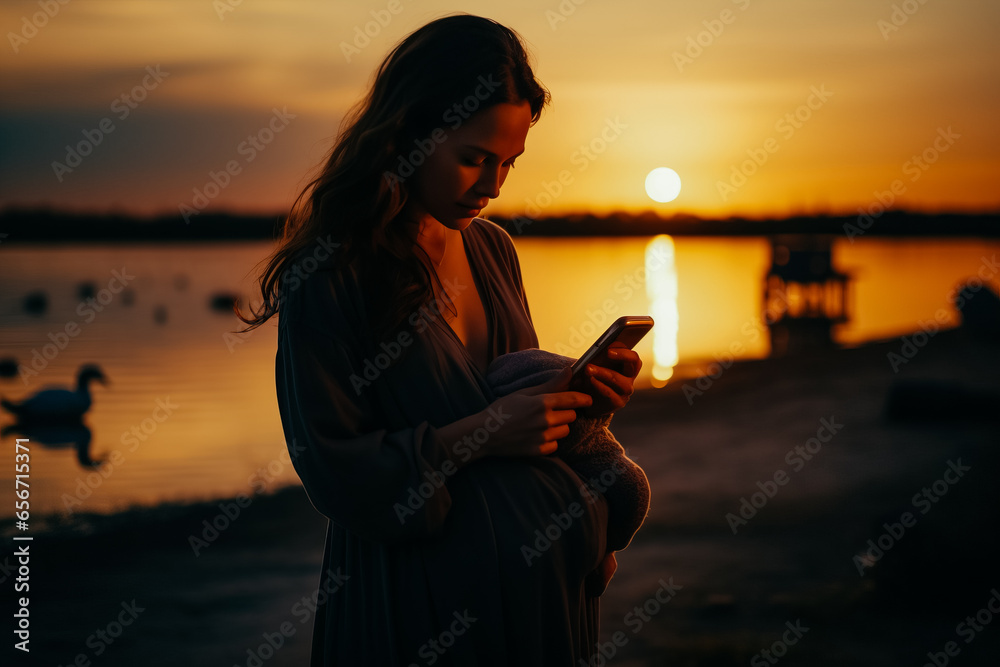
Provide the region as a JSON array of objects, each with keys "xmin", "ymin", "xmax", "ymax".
[{"xmin": 275, "ymin": 319, "xmax": 591, "ymax": 542}]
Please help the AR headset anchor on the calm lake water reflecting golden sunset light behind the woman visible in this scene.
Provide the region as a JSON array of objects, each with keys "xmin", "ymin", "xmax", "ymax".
[{"xmin": 0, "ymin": 237, "xmax": 1000, "ymax": 517}]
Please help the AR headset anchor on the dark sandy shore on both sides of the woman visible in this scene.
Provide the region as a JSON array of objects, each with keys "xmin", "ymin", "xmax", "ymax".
[{"xmin": 9, "ymin": 331, "xmax": 1000, "ymax": 667}]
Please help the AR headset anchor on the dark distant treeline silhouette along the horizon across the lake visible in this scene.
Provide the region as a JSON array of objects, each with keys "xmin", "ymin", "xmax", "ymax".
[{"xmin": 0, "ymin": 208, "xmax": 1000, "ymax": 244}]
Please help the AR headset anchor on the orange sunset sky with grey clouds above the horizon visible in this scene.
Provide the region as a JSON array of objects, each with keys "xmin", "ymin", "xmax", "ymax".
[{"xmin": 0, "ymin": 0, "xmax": 1000, "ymax": 216}]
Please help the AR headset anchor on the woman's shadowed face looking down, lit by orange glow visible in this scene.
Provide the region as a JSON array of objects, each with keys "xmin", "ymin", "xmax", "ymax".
[{"xmin": 408, "ymin": 101, "xmax": 531, "ymax": 230}]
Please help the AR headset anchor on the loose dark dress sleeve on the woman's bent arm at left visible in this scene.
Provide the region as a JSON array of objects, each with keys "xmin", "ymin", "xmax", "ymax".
[{"xmin": 275, "ymin": 276, "xmax": 451, "ymax": 542}]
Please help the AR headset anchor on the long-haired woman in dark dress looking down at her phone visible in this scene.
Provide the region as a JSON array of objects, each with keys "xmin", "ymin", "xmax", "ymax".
[{"xmin": 234, "ymin": 15, "xmax": 640, "ymax": 667}]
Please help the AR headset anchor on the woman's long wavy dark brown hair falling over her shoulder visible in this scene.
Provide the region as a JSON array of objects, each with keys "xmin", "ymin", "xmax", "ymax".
[{"xmin": 234, "ymin": 14, "xmax": 550, "ymax": 348}]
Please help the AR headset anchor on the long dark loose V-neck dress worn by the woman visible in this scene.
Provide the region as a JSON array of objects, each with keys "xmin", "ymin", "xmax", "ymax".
[{"xmin": 275, "ymin": 218, "xmax": 608, "ymax": 667}]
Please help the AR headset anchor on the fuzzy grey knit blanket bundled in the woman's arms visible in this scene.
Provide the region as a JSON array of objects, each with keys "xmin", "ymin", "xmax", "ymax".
[{"xmin": 486, "ymin": 348, "xmax": 649, "ymax": 551}]
